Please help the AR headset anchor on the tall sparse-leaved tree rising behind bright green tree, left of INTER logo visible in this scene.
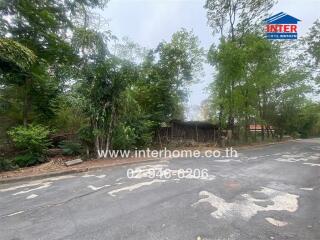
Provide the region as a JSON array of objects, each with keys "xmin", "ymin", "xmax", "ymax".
[{"xmin": 204, "ymin": 0, "xmax": 274, "ymax": 141}]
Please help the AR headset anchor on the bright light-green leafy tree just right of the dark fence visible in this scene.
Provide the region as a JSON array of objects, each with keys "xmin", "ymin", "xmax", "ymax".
[{"xmin": 209, "ymin": 34, "xmax": 279, "ymax": 141}]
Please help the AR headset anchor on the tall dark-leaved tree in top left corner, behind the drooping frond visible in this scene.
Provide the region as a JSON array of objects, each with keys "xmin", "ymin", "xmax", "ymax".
[{"xmin": 0, "ymin": 0, "xmax": 105, "ymax": 125}]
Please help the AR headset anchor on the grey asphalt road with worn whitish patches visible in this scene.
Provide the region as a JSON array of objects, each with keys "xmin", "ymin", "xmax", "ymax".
[{"xmin": 0, "ymin": 139, "xmax": 320, "ymax": 240}]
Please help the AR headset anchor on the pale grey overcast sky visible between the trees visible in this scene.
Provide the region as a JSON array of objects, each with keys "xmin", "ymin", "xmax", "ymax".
[{"xmin": 102, "ymin": 0, "xmax": 320, "ymax": 119}]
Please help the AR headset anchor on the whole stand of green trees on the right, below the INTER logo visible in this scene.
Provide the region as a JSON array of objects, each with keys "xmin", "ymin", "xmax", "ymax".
[{"xmin": 205, "ymin": 0, "xmax": 320, "ymax": 141}]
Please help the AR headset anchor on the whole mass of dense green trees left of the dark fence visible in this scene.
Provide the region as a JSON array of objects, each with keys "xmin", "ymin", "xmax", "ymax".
[{"xmin": 0, "ymin": 0, "xmax": 204, "ymax": 167}]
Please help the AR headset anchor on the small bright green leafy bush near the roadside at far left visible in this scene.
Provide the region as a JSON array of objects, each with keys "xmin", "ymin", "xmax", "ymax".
[{"xmin": 8, "ymin": 125, "xmax": 50, "ymax": 167}]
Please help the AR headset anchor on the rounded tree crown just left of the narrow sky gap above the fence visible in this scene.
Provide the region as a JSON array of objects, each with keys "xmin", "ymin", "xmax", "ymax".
[{"xmin": 138, "ymin": 29, "xmax": 204, "ymax": 123}]
